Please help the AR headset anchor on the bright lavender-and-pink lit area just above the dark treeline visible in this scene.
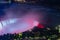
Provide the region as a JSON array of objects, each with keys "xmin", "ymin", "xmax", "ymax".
[{"xmin": 0, "ymin": 14, "xmax": 39, "ymax": 35}]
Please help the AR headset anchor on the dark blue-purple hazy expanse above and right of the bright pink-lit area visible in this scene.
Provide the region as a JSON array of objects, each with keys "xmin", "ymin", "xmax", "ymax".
[{"xmin": 0, "ymin": 0, "xmax": 60, "ymax": 33}]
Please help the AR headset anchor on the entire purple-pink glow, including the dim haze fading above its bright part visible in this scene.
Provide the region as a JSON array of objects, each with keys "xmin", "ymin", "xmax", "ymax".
[{"xmin": 0, "ymin": 5, "xmax": 45, "ymax": 35}]
